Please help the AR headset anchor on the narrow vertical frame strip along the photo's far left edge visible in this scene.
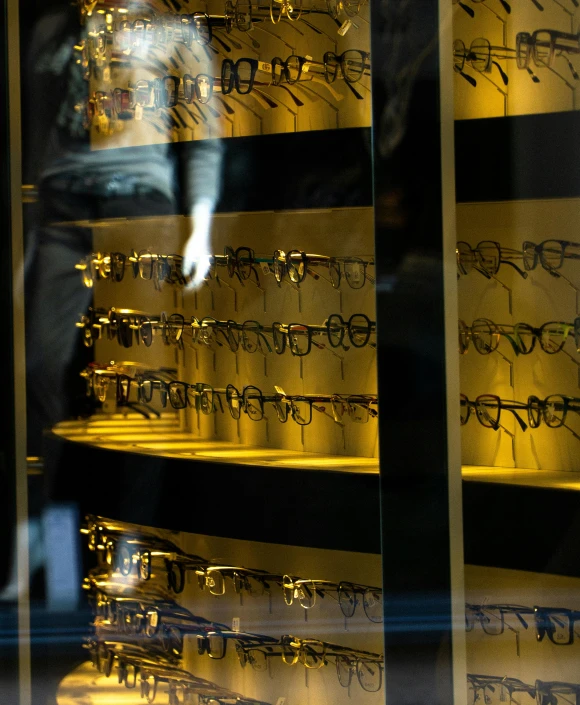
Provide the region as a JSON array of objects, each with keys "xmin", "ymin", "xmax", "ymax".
[{"xmin": 0, "ymin": 0, "xmax": 31, "ymax": 705}]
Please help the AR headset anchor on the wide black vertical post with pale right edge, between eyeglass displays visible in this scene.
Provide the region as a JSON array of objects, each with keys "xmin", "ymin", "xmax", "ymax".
[{"xmin": 371, "ymin": 0, "xmax": 466, "ymax": 705}]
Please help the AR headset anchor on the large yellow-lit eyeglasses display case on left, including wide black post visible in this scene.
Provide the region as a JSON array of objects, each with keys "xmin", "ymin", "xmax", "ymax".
[{"xmin": 4, "ymin": 0, "xmax": 466, "ymax": 705}]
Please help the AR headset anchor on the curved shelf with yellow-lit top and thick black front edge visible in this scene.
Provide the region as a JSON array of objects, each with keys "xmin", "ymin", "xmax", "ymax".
[{"xmin": 45, "ymin": 414, "xmax": 381, "ymax": 554}]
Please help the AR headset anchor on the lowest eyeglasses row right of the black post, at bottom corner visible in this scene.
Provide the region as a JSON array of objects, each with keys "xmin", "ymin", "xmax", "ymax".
[{"xmin": 467, "ymin": 673, "xmax": 580, "ymax": 705}]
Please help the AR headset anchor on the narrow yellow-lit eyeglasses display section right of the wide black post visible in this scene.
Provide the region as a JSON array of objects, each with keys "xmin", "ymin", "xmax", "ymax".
[{"xmin": 453, "ymin": 3, "xmax": 580, "ymax": 680}]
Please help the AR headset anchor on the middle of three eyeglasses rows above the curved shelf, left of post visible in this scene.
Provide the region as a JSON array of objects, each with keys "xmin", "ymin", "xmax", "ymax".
[{"xmin": 76, "ymin": 307, "xmax": 376, "ymax": 357}]
